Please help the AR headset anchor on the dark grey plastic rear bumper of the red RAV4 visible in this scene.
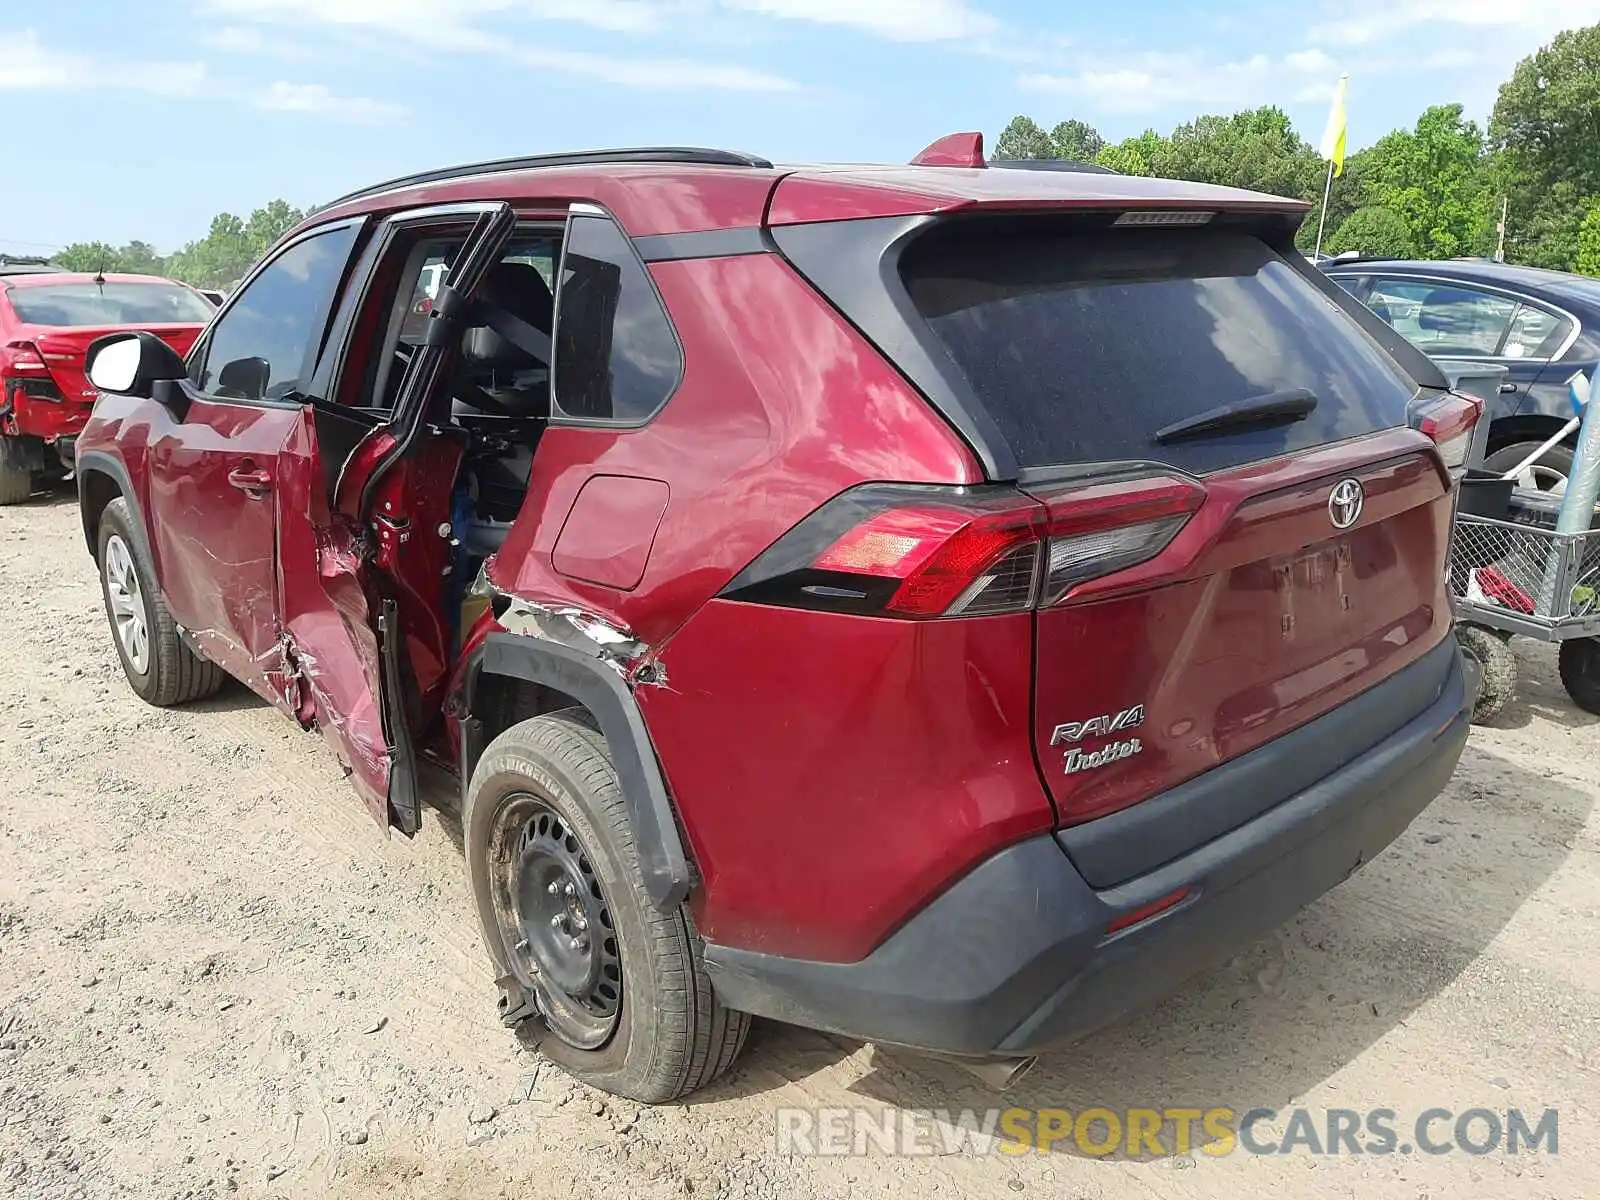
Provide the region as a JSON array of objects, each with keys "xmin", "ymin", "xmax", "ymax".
[{"xmin": 706, "ymin": 638, "xmax": 1470, "ymax": 1056}]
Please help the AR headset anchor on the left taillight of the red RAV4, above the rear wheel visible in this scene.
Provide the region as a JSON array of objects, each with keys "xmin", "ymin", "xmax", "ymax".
[{"xmin": 723, "ymin": 475, "xmax": 1205, "ymax": 619}]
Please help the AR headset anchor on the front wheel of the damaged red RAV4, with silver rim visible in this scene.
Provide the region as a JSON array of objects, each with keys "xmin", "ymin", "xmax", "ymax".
[{"xmin": 99, "ymin": 496, "xmax": 227, "ymax": 707}]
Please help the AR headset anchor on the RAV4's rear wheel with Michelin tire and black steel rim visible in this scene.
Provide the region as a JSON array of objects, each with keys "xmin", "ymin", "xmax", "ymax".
[{"xmin": 461, "ymin": 710, "xmax": 750, "ymax": 1104}]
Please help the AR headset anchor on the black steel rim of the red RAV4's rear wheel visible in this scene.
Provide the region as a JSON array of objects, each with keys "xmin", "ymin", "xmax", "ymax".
[{"xmin": 490, "ymin": 794, "xmax": 622, "ymax": 1050}]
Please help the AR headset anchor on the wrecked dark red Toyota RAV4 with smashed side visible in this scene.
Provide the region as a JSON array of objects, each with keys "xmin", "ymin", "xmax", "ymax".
[{"xmin": 78, "ymin": 136, "xmax": 1478, "ymax": 1101}]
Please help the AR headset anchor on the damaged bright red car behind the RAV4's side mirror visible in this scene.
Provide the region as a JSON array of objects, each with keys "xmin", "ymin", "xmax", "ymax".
[{"xmin": 0, "ymin": 266, "xmax": 214, "ymax": 504}]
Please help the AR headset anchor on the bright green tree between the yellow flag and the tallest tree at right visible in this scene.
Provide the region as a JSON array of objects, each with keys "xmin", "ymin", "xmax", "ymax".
[{"xmin": 1362, "ymin": 104, "xmax": 1491, "ymax": 258}]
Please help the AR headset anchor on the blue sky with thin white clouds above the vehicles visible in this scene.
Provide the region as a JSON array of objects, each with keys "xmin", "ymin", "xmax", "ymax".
[{"xmin": 0, "ymin": 0, "xmax": 1600, "ymax": 253}]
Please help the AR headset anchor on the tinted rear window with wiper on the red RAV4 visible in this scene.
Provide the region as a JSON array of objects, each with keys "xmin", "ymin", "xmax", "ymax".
[{"xmin": 901, "ymin": 224, "xmax": 1413, "ymax": 472}]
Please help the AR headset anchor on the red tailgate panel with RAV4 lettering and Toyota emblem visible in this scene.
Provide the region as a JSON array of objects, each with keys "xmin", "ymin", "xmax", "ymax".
[{"xmin": 1035, "ymin": 453, "xmax": 1451, "ymax": 824}]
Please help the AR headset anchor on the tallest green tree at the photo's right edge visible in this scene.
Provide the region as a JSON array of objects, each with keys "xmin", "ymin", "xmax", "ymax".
[{"xmin": 1490, "ymin": 26, "xmax": 1600, "ymax": 270}]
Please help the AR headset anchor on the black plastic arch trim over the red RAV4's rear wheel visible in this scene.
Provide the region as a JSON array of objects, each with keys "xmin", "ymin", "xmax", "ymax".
[{"xmin": 461, "ymin": 634, "xmax": 693, "ymax": 912}]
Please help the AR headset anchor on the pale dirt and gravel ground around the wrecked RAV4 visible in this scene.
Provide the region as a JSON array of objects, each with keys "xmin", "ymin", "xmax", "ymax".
[{"xmin": 0, "ymin": 496, "xmax": 1600, "ymax": 1200}]
